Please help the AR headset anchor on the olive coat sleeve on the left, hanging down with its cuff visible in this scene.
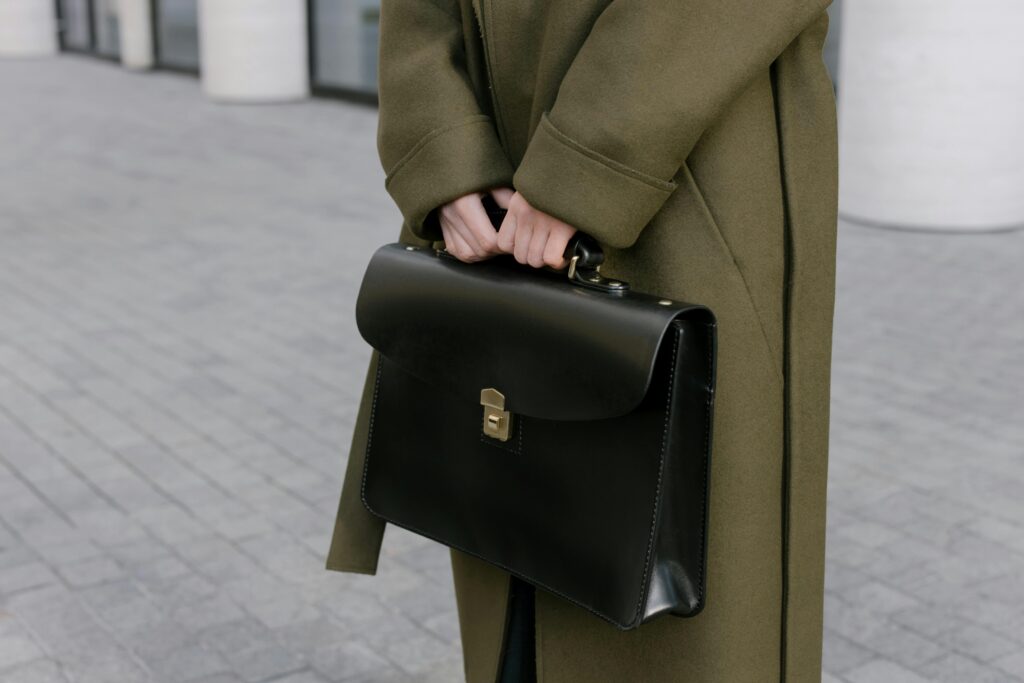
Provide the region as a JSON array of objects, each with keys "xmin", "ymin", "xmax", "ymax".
[{"xmin": 377, "ymin": 0, "xmax": 513, "ymax": 240}]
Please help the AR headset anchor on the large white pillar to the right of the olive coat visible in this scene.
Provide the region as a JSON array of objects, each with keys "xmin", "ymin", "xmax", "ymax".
[{"xmin": 839, "ymin": 0, "xmax": 1024, "ymax": 229}]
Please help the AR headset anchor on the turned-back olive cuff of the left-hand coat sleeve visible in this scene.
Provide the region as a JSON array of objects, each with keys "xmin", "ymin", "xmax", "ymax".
[{"xmin": 384, "ymin": 115, "xmax": 513, "ymax": 241}]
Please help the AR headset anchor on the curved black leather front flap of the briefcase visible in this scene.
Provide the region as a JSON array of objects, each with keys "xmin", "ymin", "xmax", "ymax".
[{"xmin": 355, "ymin": 243, "xmax": 713, "ymax": 420}]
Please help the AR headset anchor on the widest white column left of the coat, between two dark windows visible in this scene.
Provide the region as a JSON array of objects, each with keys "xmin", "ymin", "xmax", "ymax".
[{"xmin": 199, "ymin": 0, "xmax": 309, "ymax": 101}]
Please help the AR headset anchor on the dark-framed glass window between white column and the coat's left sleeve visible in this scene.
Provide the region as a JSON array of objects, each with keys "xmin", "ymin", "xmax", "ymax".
[{"xmin": 310, "ymin": 0, "xmax": 380, "ymax": 93}]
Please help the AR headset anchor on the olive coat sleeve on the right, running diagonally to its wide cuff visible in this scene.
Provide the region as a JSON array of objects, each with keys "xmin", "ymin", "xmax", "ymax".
[{"xmin": 514, "ymin": 0, "xmax": 829, "ymax": 248}]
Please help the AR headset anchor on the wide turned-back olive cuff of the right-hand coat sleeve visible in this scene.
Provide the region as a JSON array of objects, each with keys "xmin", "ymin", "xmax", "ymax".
[{"xmin": 513, "ymin": 113, "xmax": 676, "ymax": 248}]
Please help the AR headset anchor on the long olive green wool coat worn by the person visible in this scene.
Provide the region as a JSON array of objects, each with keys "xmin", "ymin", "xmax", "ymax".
[{"xmin": 328, "ymin": 0, "xmax": 837, "ymax": 683}]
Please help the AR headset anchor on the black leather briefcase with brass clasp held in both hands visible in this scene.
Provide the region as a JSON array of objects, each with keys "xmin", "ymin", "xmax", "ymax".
[{"xmin": 356, "ymin": 211, "xmax": 716, "ymax": 629}]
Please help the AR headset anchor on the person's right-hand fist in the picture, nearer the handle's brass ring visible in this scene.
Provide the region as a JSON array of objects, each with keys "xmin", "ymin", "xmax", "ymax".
[{"xmin": 492, "ymin": 187, "xmax": 577, "ymax": 268}]
